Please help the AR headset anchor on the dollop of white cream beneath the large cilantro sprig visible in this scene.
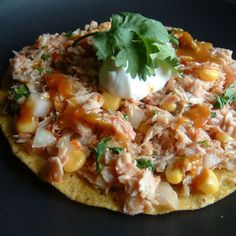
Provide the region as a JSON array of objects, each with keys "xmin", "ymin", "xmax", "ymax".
[{"xmin": 99, "ymin": 59, "xmax": 171, "ymax": 100}]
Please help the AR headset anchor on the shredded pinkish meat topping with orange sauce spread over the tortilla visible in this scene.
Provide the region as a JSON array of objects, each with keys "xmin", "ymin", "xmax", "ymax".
[{"xmin": 6, "ymin": 22, "xmax": 236, "ymax": 215}]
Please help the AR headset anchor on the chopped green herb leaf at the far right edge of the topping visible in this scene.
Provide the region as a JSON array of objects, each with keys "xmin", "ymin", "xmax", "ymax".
[{"xmin": 214, "ymin": 84, "xmax": 236, "ymax": 109}]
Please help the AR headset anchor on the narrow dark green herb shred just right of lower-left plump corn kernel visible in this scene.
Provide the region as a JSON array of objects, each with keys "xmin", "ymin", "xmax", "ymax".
[{"xmin": 92, "ymin": 137, "xmax": 111, "ymax": 174}]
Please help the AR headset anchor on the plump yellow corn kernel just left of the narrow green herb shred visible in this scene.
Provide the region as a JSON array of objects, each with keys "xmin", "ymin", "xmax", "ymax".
[{"xmin": 63, "ymin": 148, "xmax": 86, "ymax": 173}]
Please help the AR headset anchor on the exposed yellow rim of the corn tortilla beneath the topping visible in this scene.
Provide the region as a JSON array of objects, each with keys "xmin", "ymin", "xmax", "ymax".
[{"xmin": 0, "ymin": 74, "xmax": 236, "ymax": 215}]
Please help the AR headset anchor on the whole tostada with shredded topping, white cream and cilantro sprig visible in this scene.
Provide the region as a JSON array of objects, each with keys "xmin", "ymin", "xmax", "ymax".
[{"xmin": 0, "ymin": 13, "xmax": 236, "ymax": 215}]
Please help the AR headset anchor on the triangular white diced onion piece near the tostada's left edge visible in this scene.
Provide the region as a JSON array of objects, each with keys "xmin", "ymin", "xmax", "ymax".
[{"xmin": 32, "ymin": 127, "xmax": 56, "ymax": 148}]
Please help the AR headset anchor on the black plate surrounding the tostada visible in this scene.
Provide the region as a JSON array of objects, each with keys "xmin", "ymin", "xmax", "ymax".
[{"xmin": 0, "ymin": 0, "xmax": 236, "ymax": 235}]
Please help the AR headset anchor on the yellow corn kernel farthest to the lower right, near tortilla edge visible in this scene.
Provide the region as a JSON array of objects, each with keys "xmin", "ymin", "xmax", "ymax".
[{"xmin": 198, "ymin": 169, "xmax": 219, "ymax": 194}]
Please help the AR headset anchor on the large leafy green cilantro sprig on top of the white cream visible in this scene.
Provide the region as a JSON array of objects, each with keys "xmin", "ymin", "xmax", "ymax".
[{"xmin": 93, "ymin": 12, "xmax": 178, "ymax": 80}]
